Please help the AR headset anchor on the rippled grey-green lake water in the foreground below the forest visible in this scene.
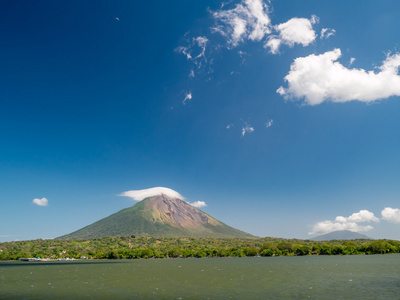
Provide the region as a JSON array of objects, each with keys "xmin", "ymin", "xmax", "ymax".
[{"xmin": 0, "ymin": 254, "xmax": 400, "ymax": 299}]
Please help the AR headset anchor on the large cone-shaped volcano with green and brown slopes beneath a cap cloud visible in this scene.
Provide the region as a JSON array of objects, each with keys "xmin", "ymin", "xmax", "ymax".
[{"xmin": 59, "ymin": 194, "xmax": 255, "ymax": 239}]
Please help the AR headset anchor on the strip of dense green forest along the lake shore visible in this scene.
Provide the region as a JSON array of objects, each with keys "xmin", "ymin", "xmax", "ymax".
[{"xmin": 0, "ymin": 236, "xmax": 400, "ymax": 260}]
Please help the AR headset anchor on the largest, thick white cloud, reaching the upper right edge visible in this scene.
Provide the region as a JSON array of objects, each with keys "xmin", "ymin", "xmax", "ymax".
[{"xmin": 277, "ymin": 49, "xmax": 400, "ymax": 105}]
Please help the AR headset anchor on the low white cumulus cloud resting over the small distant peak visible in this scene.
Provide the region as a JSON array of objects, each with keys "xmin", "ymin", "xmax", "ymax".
[{"xmin": 308, "ymin": 210, "xmax": 379, "ymax": 235}]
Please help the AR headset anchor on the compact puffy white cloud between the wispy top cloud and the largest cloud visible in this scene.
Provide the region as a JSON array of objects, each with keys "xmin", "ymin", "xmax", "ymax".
[{"xmin": 265, "ymin": 16, "xmax": 317, "ymax": 54}]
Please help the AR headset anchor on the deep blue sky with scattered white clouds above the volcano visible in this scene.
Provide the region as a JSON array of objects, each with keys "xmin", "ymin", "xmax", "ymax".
[{"xmin": 0, "ymin": 0, "xmax": 400, "ymax": 241}]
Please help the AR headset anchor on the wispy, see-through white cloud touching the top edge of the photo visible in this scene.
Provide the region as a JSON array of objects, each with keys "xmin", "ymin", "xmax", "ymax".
[{"xmin": 213, "ymin": 0, "xmax": 271, "ymax": 47}]
